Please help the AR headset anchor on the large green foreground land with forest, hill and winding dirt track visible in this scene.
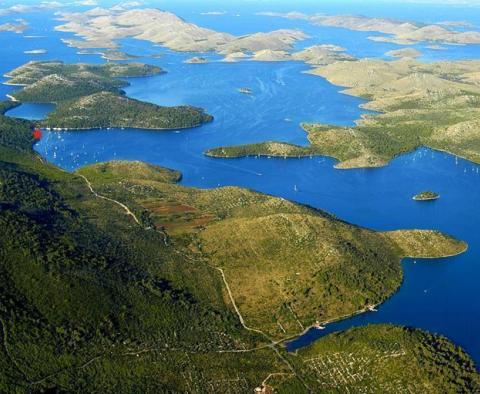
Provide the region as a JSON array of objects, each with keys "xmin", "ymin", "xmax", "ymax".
[{"xmin": 0, "ymin": 106, "xmax": 480, "ymax": 393}]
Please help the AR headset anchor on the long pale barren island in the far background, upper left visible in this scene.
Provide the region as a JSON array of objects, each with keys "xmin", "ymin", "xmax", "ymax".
[{"xmin": 55, "ymin": 7, "xmax": 307, "ymax": 55}]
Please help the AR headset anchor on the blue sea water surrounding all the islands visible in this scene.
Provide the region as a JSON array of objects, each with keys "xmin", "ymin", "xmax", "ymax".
[{"xmin": 0, "ymin": 1, "xmax": 480, "ymax": 364}]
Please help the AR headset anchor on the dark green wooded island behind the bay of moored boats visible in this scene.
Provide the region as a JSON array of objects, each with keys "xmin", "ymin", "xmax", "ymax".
[{"xmin": 7, "ymin": 62, "xmax": 213, "ymax": 130}]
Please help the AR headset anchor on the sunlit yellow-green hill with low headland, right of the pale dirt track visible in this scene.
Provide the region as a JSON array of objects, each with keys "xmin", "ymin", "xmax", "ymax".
[{"xmin": 78, "ymin": 162, "xmax": 466, "ymax": 339}]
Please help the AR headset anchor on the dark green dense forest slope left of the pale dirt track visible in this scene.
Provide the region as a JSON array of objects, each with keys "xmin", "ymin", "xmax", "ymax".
[{"xmin": 0, "ymin": 106, "xmax": 276, "ymax": 392}]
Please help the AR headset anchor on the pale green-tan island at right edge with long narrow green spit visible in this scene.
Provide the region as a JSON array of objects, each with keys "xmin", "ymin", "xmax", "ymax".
[{"xmin": 206, "ymin": 58, "xmax": 480, "ymax": 169}]
